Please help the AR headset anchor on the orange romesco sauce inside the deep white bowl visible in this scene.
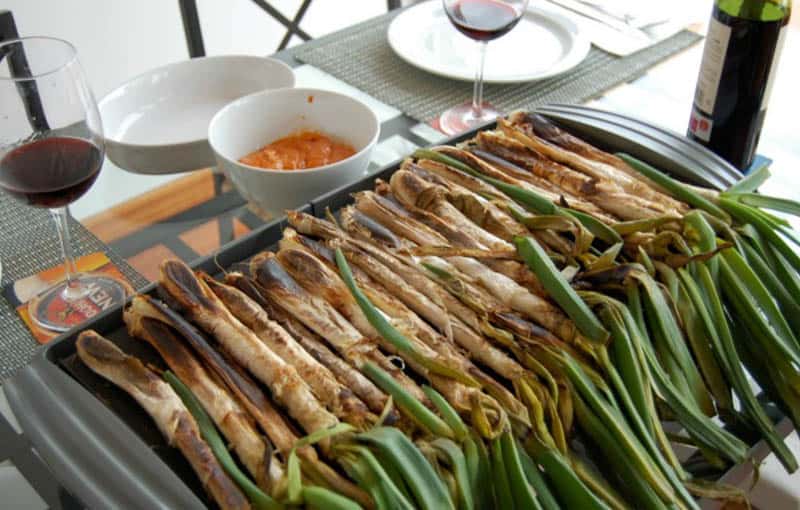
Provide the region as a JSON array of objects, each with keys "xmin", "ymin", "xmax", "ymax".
[{"xmin": 239, "ymin": 131, "xmax": 356, "ymax": 170}]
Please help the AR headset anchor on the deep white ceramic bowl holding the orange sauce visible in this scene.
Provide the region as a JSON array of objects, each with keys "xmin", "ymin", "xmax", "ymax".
[{"xmin": 208, "ymin": 89, "xmax": 380, "ymax": 217}]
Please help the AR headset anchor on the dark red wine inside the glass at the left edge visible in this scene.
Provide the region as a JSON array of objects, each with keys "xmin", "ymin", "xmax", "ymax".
[{"xmin": 0, "ymin": 136, "xmax": 103, "ymax": 209}]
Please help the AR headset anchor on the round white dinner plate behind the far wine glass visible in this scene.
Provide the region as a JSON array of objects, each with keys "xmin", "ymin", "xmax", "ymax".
[{"xmin": 388, "ymin": 0, "xmax": 590, "ymax": 83}]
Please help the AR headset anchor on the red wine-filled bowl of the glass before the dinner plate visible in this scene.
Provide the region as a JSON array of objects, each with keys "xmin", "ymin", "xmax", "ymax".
[{"xmin": 446, "ymin": 0, "xmax": 521, "ymax": 41}]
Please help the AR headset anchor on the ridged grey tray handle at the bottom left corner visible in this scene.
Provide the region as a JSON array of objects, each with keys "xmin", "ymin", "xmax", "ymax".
[{"xmin": 3, "ymin": 353, "xmax": 204, "ymax": 510}]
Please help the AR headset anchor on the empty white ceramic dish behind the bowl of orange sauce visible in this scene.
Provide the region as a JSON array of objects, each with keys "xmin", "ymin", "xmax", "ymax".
[{"xmin": 99, "ymin": 55, "xmax": 294, "ymax": 174}]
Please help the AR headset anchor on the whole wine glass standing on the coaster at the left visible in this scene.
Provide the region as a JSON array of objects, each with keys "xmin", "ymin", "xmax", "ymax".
[{"xmin": 0, "ymin": 37, "xmax": 127, "ymax": 331}]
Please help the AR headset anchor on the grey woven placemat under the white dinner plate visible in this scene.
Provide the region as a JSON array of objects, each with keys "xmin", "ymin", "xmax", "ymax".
[{"xmin": 293, "ymin": 13, "xmax": 701, "ymax": 122}]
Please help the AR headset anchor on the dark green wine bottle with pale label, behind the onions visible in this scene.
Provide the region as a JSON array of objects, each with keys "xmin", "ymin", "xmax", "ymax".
[{"xmin": 687, "ymin": 0, "xmax": 792, "ymax": 170}]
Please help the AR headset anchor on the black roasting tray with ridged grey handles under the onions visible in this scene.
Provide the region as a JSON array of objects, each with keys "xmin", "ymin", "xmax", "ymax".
[{"xmin": 4, "ymin": 108, "xmax": 792, "ymax": 509}]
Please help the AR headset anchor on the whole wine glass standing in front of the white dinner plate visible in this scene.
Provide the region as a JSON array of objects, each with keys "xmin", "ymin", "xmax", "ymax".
[{"xmin": 439, "ymin": 0, "xmax": 528, "ymax": 135}]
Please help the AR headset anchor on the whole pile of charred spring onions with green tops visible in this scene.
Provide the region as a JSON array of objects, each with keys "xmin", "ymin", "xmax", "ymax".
[{"xmin": 73, "ymin": 113, "xmax": 800, "ymax": 510}]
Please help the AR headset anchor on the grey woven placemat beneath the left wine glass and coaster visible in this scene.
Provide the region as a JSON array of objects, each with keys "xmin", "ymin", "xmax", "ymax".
[{"xmin": 0, "ymin": 191, "xmax": 147, "ymax": 382}]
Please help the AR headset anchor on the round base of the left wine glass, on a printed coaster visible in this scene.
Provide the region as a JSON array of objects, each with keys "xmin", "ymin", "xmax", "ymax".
[{"xmin": 28, "ymin": 273, "xmax": 129, "ymax": 332}]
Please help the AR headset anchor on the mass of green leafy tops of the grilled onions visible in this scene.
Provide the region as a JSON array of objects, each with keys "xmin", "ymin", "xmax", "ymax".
[{"xmin": 310, "ymin": 150, "xmax": 800, "ymax": 509}]
